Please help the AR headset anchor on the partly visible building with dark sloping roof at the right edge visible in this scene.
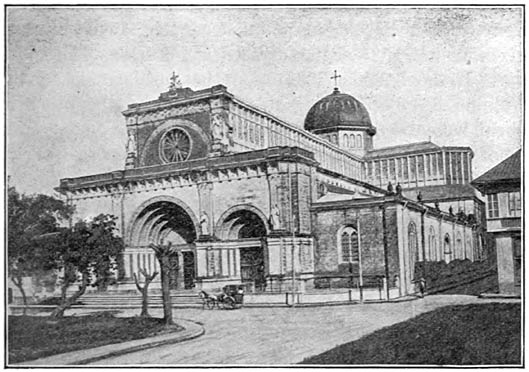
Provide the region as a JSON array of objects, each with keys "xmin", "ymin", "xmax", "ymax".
[{"xmin": 472, "ymin": 150, "xmax": 522, "ymax": 294}]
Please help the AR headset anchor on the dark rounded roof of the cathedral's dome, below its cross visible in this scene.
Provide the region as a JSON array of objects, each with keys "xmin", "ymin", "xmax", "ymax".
[{"xmin": 304, "ymin": 88, "xmax": 375, "ymax": 134}]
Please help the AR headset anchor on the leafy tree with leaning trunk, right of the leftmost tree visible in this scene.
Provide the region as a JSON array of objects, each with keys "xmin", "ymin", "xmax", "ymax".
[{"xmin": 45, "ymin": 214, "xmax": 124, "ymax": 317}]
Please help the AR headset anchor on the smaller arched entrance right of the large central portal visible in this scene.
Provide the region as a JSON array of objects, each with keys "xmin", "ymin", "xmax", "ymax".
[{"xmin": 220, "ymin": 208, "xmax": 267, "ymax": 291}]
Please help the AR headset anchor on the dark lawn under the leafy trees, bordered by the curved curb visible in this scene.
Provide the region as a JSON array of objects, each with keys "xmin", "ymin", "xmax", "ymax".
[{"xmin": 8, "ymin": 314, "xmax": 178, "ymax": 363}]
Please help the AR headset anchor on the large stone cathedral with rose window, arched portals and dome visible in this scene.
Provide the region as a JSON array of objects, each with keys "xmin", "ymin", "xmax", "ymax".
[{"xmin": 57, "ymin": 74, "xmax": 485, "ymax": 298}]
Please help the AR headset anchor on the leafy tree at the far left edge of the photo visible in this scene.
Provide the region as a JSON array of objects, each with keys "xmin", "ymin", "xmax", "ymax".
[{"xmin": 7, "ymin": 187, "xmax": 73, "ymax": 314}]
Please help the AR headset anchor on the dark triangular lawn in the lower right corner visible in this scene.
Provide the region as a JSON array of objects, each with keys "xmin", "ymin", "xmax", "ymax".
[{"xmin": 301, "ymin": 303, "xmax": 521, "ymax": 365}]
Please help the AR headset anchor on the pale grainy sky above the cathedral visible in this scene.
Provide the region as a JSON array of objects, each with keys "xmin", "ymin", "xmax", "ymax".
[{"xmin": 7, "ymin": 7, "xmax": 522, "ymax": 193}]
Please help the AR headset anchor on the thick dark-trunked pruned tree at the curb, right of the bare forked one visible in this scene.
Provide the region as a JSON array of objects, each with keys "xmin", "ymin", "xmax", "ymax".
[{"xmin": 150, "ymin": 241, "xmax": 178, "ymax": 326}]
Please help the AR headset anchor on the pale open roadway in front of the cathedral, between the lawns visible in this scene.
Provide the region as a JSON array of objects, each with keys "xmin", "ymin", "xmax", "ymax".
[{"xmin": 81, "ymin": 295, "xmax": 520, "ymax": 366}]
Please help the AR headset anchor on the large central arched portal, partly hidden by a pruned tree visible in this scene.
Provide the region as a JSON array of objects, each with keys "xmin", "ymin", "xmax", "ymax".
[{"xmin": 125, "ymin": 199, "xmax": 197, "ymax": 289}]
